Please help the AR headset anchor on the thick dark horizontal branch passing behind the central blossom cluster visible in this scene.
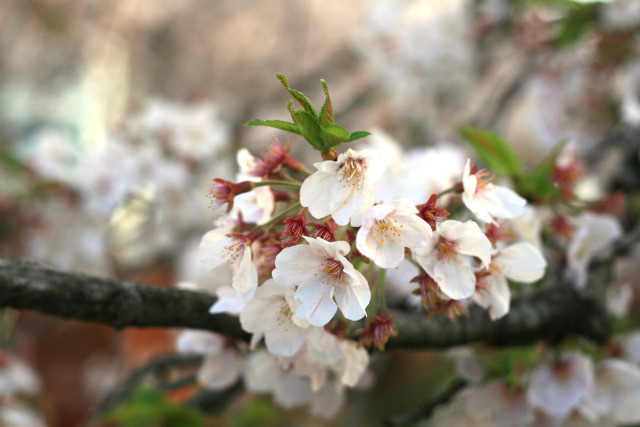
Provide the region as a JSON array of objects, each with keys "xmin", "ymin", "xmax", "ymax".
[{"xmin": 0, "ymin": 260, "xmax": 608, "ymax": 349}]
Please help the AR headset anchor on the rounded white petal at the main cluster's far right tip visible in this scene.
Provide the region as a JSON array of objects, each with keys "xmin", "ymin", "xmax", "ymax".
[{"xmin": 492, "ymin": 242, "xmax": 547, "ymax": 283}]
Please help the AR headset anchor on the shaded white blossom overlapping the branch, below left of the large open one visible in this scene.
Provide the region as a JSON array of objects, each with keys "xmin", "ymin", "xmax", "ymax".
[{"xmin": 240, "ymin": 280, "xmax": 309, "ymax": 356}]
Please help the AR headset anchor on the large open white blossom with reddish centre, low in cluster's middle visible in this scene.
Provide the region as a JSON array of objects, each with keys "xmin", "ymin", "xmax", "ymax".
[{"xmin": 273, "ymin": 237, "xmax": 371, "ymax": 326}]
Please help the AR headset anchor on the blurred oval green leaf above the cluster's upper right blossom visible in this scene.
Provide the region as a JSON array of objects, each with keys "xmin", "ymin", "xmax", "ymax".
[{"xmin": 460, "ymin": 127, "xmax": 522, "ymax": 177}]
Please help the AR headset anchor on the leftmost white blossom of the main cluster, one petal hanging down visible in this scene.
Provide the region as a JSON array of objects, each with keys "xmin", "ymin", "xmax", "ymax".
[{"xmin": 200, "ymin": 226, "xmax": 258, "ymax": 302}]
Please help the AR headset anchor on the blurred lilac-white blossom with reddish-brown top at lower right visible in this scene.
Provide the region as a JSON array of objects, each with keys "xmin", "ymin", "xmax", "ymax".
[{"xmin": 527, "ymin": 352, "xmax": 594, "ymax": 419}]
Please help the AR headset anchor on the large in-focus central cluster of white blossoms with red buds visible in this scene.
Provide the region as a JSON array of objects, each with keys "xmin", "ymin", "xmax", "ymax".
[{"xmin": 196, "ymin": 77, "xmax": 546, "ymax": 414}]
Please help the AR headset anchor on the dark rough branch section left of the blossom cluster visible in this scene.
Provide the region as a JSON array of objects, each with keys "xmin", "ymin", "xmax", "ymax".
[{"xmin": 0, "ymin": 259, "xmax": 249, "ymax": 341}]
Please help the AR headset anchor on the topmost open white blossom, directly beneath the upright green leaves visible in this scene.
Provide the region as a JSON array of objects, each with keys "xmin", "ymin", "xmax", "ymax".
[{"xmin": 300, "ymin": 148, "xmax": 389, "ymax": 226}]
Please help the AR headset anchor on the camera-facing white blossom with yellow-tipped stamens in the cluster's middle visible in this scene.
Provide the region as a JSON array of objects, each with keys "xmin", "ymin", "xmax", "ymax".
[{"xmin": 356, "ymin": 200, "xmax": 432, "ymax": 268}]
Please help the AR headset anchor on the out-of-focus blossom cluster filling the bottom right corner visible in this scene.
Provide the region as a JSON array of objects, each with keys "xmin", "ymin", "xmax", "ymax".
[{"xmin": 436, "ymin": 332, "xmax": 640, "ymax": 427}]
